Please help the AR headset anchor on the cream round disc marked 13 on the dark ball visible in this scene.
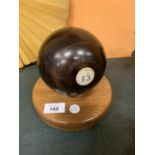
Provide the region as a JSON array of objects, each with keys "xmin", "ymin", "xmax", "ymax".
[{"xmin": 76, "ymin": 67, "xmax": 95, "ymax": 86}]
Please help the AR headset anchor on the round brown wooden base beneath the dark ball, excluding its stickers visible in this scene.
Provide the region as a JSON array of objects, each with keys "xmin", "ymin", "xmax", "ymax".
[{"xmin": 32, "ymin": 77, "xmax": 112, "ymax": 131}]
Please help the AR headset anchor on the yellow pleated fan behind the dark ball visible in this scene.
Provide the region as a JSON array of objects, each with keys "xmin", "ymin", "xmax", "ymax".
[{"xmin": 19, "ymin": 0, "xmax": 69, "ymax": 68}]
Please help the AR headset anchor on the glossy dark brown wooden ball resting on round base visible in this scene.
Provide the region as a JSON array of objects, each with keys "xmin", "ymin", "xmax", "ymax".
[{"xmin": 38, "ymin": 27, "xmax": 106, "ymax": 96}]
